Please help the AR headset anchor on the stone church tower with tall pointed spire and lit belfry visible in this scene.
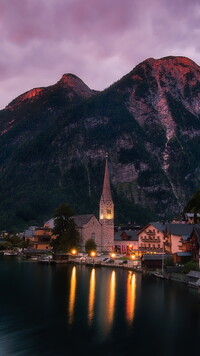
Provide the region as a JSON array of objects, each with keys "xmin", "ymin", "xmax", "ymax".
[{"xmin": 99, "ymin": 154, "xmax": 114, "ymax": 251}]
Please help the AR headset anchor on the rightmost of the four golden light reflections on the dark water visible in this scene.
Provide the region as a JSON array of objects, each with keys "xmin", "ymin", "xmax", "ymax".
[{"xmin": 126, "ymin": 272, "xmax": 136, "ymax": 323}]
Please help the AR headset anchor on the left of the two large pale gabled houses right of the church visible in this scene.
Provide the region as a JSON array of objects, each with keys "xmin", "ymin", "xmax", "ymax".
[{"xmin": 138, "ymin": 222, "xmax": 165, "ymax": 254}]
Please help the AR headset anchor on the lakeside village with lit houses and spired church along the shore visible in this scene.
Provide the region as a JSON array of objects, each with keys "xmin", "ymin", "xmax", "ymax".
[{"xmin": 0, "ymin": 157, "xmax": 200, "ymax": 288}]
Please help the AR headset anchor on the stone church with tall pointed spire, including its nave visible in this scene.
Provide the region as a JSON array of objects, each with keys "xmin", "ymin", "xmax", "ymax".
[{"xmin": 45, "ymin": 154, "xmax": 114, "ymax": 252}]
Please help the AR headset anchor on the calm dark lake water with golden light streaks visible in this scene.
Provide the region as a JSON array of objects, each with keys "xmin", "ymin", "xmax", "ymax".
[{"xmin": 0, "ymin": 257, "xmax": 200, "ymax": 356}]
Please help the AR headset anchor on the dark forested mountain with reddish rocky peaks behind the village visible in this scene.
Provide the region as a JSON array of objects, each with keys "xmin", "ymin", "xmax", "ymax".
[{"xmin": 0, "ymin": 57, "xmax": 200, "ymax": 228}]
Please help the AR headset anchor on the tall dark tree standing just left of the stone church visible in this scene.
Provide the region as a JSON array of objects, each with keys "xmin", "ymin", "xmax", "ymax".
[{"xmin": 52, "ymin": 203, "xmax": 81, "ymax": 252}]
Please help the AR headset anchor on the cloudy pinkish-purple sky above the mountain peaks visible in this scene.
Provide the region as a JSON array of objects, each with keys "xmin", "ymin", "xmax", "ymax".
[{"xmin": 0, "ymin": 0, "xmax": 200, "ymax": 109}]
